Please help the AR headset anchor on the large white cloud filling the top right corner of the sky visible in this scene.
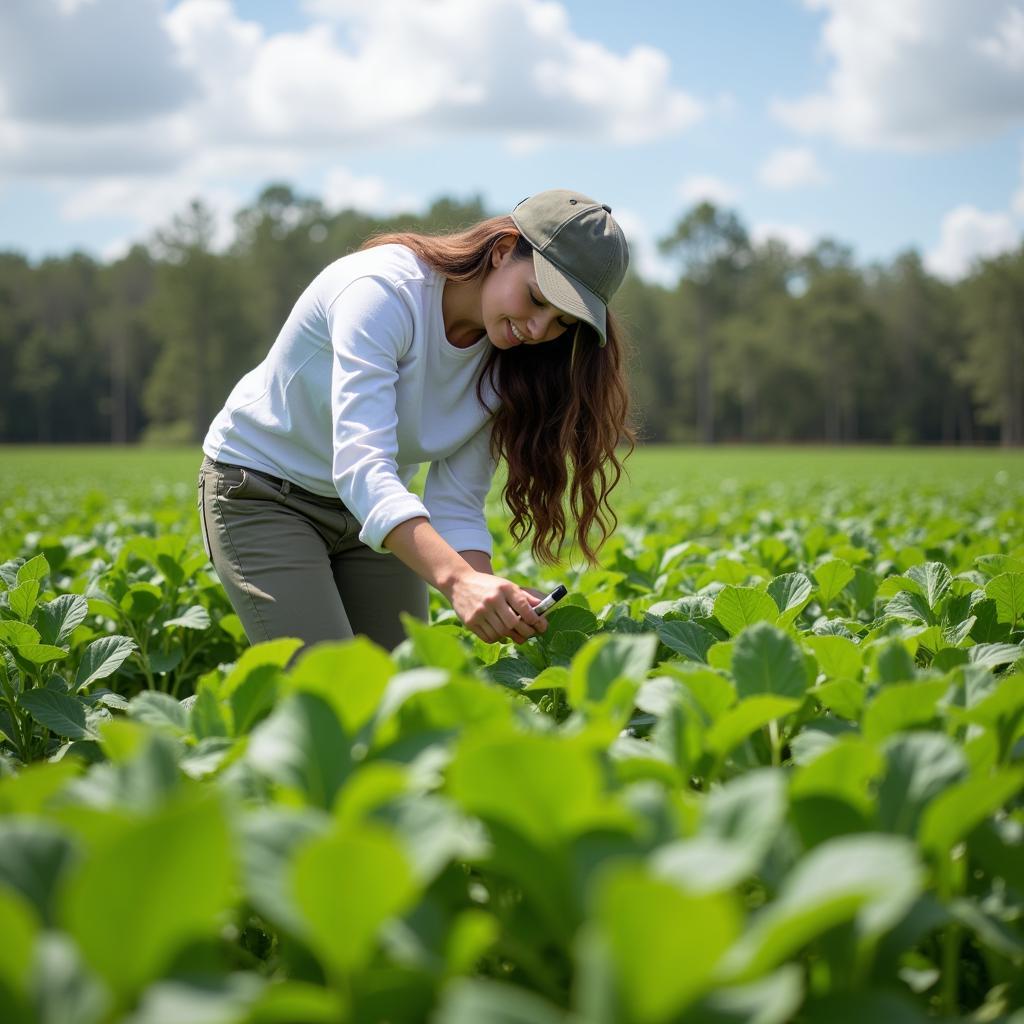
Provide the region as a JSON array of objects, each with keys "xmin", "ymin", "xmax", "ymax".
[{"xmin": 772, "ymin": 0, "xmax": 1024, "ymax": 151}]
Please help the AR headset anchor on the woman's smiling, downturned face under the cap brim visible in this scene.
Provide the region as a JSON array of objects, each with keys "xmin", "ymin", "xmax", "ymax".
[{"xmin": 481, "ymin": 237, "xmax": 578, "ymax": 348}]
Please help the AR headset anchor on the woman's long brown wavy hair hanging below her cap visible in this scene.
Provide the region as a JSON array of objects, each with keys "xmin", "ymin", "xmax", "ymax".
[{"xmin": 362, "ymin": 216, "xmax": 636, "ymax": 565}]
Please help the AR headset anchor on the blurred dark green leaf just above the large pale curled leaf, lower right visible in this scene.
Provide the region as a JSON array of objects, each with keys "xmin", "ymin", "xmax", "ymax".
[{"xmin": 879, "ymin": 732, "xmax": 967, "ymax": 836}]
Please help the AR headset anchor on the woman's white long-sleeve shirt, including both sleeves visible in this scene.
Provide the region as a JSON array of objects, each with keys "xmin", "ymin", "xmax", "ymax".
[{"xmin": 203, "ymin": 245, "xmax": 497, "ymax": 555}]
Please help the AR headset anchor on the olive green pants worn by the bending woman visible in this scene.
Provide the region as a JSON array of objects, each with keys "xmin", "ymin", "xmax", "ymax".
[{"xmin": 199, "ymin": 458, "xmax": 427, "ymax": 649}]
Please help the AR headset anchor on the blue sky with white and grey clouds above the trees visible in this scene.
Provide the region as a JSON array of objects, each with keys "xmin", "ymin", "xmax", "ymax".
[{"xmin": 0, "ymin": 0, "xmax": 1024, "ymax": 284}]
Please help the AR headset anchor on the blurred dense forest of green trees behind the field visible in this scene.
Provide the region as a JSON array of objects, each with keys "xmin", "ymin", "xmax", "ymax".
[{"xmin": 0, "ymin": 184, "xmax": 1024, "ymax": 444}]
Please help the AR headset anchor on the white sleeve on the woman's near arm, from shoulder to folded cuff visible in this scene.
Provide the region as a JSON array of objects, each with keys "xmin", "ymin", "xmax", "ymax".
[{"xmin": 327, "ymin": 278, "xmax": 430, "ymax": 551}]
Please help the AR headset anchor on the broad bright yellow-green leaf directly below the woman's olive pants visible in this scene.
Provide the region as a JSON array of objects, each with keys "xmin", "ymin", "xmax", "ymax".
[{"xmin": 286, "ymin": 637, "xmax": 397, "ymax": 734}]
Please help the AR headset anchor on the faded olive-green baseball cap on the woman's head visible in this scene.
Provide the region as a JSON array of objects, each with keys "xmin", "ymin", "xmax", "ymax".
[{"xmin": 512, "ymin": 188, "xmax": 630, "ymax": 348}]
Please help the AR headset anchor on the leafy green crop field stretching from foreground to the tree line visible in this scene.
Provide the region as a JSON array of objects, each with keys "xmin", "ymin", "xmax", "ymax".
[{"xmin": 0, "ymin": 447, "xmax": 1024, "ymax": 1024}]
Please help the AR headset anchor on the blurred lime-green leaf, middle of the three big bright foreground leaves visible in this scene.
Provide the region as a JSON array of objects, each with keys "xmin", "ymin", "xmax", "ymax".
[{"xmin": 291, "ymin": 824, "xmax": 419, "ymax": 975}]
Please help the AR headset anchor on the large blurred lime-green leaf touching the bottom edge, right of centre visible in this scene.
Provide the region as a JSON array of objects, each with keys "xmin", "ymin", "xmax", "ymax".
[{"xmin": 592, "ymin": 865, "xmax": 741, "ymax": 1024}]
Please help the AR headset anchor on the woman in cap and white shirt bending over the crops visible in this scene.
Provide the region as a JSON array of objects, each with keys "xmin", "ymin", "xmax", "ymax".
[{"xmin": 199, "ymin": 189, "xmax": 633, "ymax": 648}]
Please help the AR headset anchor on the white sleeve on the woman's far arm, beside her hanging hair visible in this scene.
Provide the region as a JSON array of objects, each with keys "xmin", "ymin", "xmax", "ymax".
[{"xmin": 423, "ymin": 422, "xmax": 495, "ymax": 555}]
